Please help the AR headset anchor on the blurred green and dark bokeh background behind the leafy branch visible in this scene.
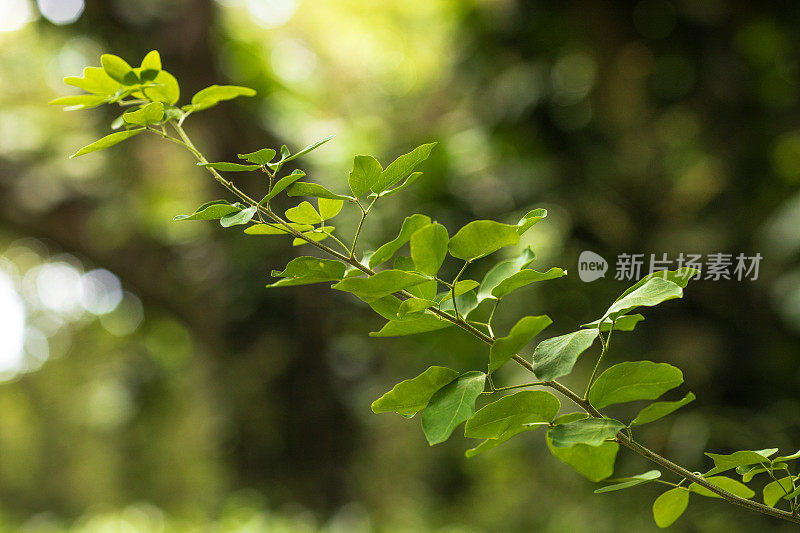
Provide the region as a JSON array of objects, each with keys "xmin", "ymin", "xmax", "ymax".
[{"xmin": 0, "ymin": 0, "xmax": 800, "ymax": 533}]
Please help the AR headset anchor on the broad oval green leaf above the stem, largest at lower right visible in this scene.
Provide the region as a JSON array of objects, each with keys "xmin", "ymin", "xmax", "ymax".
[{"xmin": 589, "ymin": 360, "xmax": 683, "ymax": 409}]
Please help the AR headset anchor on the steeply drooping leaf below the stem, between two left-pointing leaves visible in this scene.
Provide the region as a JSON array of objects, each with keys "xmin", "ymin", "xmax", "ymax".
[{"xmin": 422, "ymin": 372, "xmax": 486, "ymax": 446}]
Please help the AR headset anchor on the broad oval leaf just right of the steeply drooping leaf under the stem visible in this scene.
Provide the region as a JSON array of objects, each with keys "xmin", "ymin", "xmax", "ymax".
[{"xmin": 464, "ymin": 391, "xmax": 561, "ymax": 439}]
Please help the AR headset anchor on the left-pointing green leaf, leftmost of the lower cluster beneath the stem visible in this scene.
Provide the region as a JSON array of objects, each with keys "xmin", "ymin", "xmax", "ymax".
[{"xmin": 372, "ymin": 366, "xmax": 458, "ymax": 417}]
